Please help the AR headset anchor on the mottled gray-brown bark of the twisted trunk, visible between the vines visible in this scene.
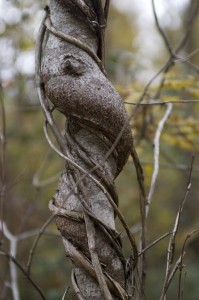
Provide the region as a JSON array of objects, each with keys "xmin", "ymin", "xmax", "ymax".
[{"xmin": 42, "ymin": 0, "xmax": 132, "ymax": 299}]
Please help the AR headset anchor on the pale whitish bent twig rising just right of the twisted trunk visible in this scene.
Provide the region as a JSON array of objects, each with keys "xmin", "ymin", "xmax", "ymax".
[{"xmin": 146, "ymin": 103, "xmax": 173, "ymax": 218}]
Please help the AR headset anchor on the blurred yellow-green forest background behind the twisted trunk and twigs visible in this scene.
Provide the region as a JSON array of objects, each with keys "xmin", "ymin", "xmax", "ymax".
[{"xmin": 0, "ymin": 0, "xmax": 199, "ymax": 300}]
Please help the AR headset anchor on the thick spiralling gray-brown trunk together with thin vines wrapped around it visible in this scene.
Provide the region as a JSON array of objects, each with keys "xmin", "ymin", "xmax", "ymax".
[{"xmin": 36, "ymin": 0, "xmax": 137, "ymax": 299}]
